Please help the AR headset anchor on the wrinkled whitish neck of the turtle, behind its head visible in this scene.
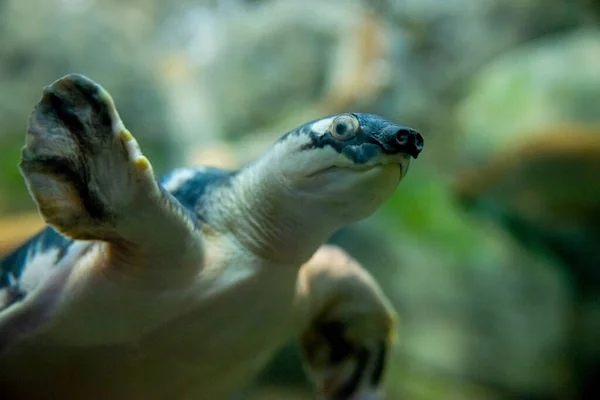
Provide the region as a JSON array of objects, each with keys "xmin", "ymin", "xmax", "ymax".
[{"xmin": 205, "ymin": 161, "xmax": 342, "ymax": 265}]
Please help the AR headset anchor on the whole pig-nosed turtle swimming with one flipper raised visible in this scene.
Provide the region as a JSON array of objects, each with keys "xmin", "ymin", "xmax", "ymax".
[{"xmin": 0, "ymin": 74, "xmax": 423, "ymax": 400}]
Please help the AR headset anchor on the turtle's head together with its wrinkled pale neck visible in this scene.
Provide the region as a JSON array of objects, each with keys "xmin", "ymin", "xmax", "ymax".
[{"xmin": 213, "ymin": 113, "xmax": 423, "ymax": 265}]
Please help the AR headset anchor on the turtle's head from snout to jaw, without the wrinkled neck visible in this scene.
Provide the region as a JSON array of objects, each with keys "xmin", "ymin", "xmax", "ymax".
[{"xmin": 274, "ymin": 113, "xmax": 423, "ymax": 222}]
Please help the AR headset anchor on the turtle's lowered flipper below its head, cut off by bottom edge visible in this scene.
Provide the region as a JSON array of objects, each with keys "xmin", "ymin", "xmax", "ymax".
[{"xmin": 296, "ymin": 245, "xmax": 396, "ymax": 400}]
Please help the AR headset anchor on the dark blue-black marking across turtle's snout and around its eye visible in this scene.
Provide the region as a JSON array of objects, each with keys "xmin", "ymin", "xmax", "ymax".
[{"xmin": 280, "ymin": 113, "xmax": 423, "ymax": 164}]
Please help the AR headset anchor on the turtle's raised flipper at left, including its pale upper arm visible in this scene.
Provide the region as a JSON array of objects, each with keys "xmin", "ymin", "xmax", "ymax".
[{"xmin": 20, "ymin": 74, "xmax": 201, "ymax": 282}]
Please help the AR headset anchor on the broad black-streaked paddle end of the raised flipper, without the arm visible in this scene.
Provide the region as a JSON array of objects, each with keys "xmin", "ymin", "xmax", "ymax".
[{"xmin": 19, "ymin": 74, "xmax": 160, "ymax": 240}]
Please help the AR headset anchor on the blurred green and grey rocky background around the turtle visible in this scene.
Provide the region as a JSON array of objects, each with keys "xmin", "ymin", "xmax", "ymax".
[{"xmin": 0, "ymin": 0, "xmax": 600, "ymax": 400}]
